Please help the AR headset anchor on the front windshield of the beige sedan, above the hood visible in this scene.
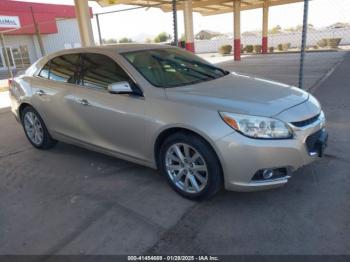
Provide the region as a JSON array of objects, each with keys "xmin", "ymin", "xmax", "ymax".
[{"xmin": 122, "ymin": 48, "xmax": 228, "ymax": 88}]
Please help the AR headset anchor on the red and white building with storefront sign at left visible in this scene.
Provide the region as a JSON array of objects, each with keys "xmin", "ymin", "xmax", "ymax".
[{"xmin": 0, "ymin": 0, "xmax": 87, "ymax": 70}]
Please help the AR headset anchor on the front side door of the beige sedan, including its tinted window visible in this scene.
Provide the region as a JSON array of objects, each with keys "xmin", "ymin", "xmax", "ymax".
[{"xmin": 66, "ymin": 53, "xmax": 146, "ymax": 161}]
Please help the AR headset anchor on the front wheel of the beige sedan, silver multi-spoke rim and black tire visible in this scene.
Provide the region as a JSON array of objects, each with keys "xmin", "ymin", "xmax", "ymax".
[{"xmin": 159, "ymin": 133, "xmax": 223, "ymax": 200}]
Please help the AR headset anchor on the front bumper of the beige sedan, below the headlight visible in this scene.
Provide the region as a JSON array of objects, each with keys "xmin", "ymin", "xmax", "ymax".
[{"xmin": 216, "ymin": 115, "xmax": 328, "ymax": 191}]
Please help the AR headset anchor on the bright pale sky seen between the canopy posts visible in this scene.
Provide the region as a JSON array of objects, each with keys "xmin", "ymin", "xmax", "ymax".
[{"xmin": 17, "ymin": 0, "xmax": 350, "ymax": 39}]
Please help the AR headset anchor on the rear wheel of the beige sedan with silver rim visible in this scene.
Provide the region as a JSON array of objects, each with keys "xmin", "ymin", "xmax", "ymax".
[{"xmin": 21, "ymin": 106, "xmax": 57, "ymax": 150}]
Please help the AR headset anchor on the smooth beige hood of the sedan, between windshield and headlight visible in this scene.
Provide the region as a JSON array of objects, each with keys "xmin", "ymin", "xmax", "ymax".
[{"xmin": 166, "ymin": 73, "xmax": 309, "ymax": 116}]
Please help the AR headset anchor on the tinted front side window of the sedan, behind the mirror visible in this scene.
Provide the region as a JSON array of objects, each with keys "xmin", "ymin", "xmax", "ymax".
[{"xmin": 81, "ymin": 53, "xmax": 129, "ymax": 89}]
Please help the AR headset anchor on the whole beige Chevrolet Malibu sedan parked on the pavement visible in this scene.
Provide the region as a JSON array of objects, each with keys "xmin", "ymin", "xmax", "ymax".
[{"xmin": 10, "ymin": 44, "xmax": 328, "ymax": 199}]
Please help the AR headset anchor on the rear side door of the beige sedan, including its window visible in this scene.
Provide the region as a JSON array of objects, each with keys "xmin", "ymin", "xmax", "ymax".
[{"xmin": 32, "ymin": 54, "xmax": 83, "ymax": 138}]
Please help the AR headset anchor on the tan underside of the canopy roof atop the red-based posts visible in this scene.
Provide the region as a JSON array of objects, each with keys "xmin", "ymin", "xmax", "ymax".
[{"xmin": 94, "ymin": 0, "xmax": 304, "ymax": 15}]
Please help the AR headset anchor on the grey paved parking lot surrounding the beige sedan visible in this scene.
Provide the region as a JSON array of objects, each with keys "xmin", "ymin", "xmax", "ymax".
[{"xmin": 0, "ymin": 52, "xmax": 350, "ymax": 255}]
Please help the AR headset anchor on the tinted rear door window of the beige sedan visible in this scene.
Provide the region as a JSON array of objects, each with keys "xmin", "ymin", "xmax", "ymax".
[{"xmin": 49, "ymin": 54, "xmax": 79, "ymax": 84}]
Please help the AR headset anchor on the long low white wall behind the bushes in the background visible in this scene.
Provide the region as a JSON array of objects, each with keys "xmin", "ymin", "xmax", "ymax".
[{"xmin": 195, "ymin": 28, "xmax": 350, "ymax": 53}]
